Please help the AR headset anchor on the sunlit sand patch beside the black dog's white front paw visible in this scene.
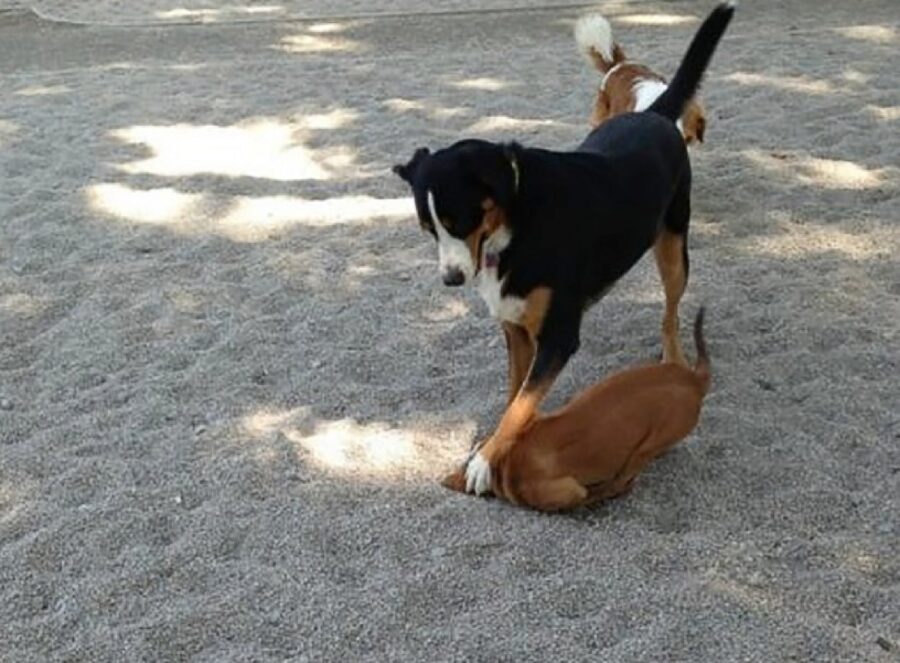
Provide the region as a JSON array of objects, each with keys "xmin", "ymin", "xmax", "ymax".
[{"xmin": 243, "ymin": 407, "xmax": 474, "ymax": 477}]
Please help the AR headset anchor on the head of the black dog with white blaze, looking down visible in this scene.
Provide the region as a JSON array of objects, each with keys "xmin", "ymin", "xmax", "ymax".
[{"xmin": 394, "ymin": 140, "xmax": 519, "ymax": 286}]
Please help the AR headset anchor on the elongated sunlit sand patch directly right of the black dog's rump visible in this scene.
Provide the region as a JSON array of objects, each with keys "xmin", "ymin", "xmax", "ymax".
[{"xmin": 742, "ymin": 149, "xmax": 898, "ymax": 189}]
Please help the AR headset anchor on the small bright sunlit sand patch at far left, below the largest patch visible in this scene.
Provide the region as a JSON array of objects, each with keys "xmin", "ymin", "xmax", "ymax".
[{"xmin": 85, "ymin": 184, "xmax": 203, "ymax": 225}]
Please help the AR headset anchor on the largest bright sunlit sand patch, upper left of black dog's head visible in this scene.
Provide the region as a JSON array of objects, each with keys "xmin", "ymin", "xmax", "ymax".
[{"xmin": 112, "ymin": 116, "xmax": 336, "ymax": 181}]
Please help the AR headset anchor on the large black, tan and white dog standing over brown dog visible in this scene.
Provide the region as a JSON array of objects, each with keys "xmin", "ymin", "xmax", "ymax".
[{"xmin": 394, "ymin": 3, "xmax": 734, "ymax": 493}]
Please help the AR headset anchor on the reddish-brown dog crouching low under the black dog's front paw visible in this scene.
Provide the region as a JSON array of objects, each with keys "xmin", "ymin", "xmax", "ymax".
[{"xmin": 442, "ymin": 308, "xmax": 709, "ymax": 511}]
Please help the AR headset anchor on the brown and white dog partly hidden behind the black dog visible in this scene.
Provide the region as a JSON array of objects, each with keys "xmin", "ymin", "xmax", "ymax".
[{"xmin": 575, "ymin": 13, "xmax": 706, "ymax": 145}]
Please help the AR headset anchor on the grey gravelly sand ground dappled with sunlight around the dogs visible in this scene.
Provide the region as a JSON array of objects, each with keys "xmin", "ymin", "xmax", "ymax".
[{"xmin": 0, "ymin": 0, "xmax": 900, "ymax": 663}]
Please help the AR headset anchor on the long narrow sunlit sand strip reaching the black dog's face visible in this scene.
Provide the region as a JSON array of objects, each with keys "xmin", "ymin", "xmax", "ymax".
[{"xmin": 217, "ymin": 196, "xmax": 414, "ymax": 242}]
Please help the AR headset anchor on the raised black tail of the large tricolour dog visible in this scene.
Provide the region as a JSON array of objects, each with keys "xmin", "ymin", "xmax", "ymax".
[{"xmin": 647, "ymin": 2, "xmax": 736, "ymax": 122}]
